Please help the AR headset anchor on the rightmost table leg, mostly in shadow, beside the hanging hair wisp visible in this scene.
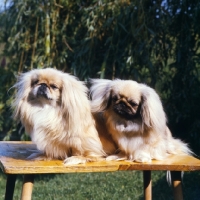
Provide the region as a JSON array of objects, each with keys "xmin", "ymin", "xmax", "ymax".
[{"xmin": 171, "ymin": 171, "xmax": 183, "ymax": 200}]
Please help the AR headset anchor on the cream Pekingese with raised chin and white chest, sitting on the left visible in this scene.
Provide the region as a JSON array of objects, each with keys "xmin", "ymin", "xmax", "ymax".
[{"xmin": 12, "ymin": 68, "xmax": 105, "ymax": 165}]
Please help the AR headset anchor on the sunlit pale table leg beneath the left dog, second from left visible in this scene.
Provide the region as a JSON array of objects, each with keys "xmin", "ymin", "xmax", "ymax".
[{"xmin": 21, "ymin": 174, "xmax": 34, "ymax": 200}]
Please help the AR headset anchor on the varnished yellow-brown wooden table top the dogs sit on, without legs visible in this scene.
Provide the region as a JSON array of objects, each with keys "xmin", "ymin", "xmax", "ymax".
[{"xmin": 0, "ymin": 141, "xmax": 200, "ymax": 174}]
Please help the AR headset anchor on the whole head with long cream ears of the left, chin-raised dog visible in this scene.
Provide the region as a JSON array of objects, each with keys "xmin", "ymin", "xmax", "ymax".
[{"xmin": 12, "ymin": 68, "xmax": 97, "ymax": 132}]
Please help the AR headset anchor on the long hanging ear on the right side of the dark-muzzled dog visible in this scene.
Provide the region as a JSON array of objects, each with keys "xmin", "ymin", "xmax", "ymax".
[{"xmin": 140, "ymin": 84, "xmax": 166, "ymax": 132}]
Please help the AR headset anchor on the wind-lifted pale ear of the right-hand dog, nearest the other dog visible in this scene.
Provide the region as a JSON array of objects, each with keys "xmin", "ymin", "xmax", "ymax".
[{"xmin": 90, "ymin": 79, "xmax": 112, "ymax": 113}]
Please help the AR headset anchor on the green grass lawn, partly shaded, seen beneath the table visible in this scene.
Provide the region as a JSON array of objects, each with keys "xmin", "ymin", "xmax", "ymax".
[{"xmin": 0, "ymin": 171, "xmax": 200, "ymax": 200}]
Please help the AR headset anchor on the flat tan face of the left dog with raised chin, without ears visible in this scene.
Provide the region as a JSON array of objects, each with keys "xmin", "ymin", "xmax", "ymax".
[{"xmin": 28, "ymin": 70, "xmax": 62, "ymax": 104}]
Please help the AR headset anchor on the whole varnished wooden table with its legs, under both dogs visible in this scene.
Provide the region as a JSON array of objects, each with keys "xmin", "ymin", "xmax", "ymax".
[{"xmin": 0, "ymin": 141, "xmax": 200, "ymax": 200}]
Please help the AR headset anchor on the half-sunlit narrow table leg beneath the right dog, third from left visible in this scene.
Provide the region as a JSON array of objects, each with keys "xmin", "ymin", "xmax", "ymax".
[{"xmin": 143, "ymin": 170, "xmax": 152, "ymax": 200}]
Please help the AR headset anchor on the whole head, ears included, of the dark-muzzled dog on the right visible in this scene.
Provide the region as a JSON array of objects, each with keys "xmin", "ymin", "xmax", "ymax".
[{"xmin": 91, "ymin": 79, "xmax": 166, "ymax": 134}]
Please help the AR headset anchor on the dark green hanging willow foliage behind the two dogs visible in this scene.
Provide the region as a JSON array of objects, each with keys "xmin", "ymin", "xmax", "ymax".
[{"xmin": 0, "ymin": 0, "xmax": 200, "ymax": 154}]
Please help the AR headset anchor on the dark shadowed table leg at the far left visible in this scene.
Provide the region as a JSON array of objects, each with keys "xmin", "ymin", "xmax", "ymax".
[{"xmin": 5, "ymin": 174, "xmax": 17, "ymax": 200}]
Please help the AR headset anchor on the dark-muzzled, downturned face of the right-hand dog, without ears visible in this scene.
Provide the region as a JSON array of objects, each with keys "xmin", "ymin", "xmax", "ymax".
[{"xmin": 108, "ymin": 81, "xmax": 142, "ymax": 120}]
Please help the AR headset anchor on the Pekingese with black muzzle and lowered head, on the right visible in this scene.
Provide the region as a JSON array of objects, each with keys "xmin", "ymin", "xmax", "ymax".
[{"xmin": 90, "ymin": 79, "xmax": 192, "ymax": 162}]
